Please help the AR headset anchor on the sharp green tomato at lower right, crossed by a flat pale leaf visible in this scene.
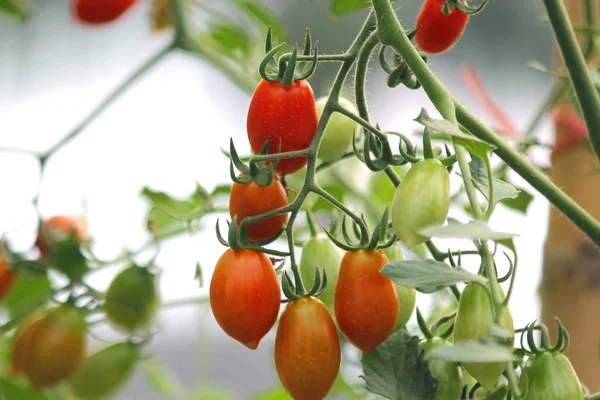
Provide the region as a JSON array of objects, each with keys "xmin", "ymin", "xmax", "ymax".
[{"xmin": 454, "ymin": 283, "xmax": 515, "ymax": 391}]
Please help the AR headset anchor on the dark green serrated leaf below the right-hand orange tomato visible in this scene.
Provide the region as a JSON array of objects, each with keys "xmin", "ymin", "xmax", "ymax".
[{"xmin": 361, "ymin": 329, "xmax": 437, "ymax": 400}]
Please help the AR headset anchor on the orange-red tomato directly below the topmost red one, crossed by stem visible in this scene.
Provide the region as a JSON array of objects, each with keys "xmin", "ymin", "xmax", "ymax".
[{"xmin": 229, "ymin": 178, "xmax": 288, "ymax": 242}]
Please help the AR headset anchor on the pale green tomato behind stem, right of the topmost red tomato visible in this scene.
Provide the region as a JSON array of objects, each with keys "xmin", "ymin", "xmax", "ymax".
[{"xmin": 317, "ymin": 97, "xmax": 358, "ymax": 162}]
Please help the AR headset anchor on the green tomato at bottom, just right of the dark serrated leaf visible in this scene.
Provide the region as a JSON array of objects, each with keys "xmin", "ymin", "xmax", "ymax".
[{"xmin": 419, "ymin": 338, "xmax": 463, "ymax": 400}]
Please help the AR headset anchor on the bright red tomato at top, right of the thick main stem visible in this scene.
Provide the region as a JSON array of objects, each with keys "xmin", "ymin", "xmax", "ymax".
[{"xmin": 415, "ymin": 0, "xmax": 469, "ymax": 54}]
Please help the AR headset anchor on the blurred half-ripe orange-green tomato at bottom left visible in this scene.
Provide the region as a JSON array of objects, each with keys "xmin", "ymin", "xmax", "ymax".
[{"xmin": 12, "ymin": 305, "xmax": 87, "ymax": 390}]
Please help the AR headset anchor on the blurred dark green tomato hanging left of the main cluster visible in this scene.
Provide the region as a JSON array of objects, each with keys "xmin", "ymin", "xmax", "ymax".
[{"xmin": 104, "ymin": 265, "xmax": 160, "ymax": 333}]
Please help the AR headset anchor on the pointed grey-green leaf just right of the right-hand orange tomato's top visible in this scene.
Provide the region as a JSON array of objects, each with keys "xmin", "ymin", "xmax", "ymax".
[{"xmin": 381, "ymin": 260, "xmax": 487, "ymax": 293}]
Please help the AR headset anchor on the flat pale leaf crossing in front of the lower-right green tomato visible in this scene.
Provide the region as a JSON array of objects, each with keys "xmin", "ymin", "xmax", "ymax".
[{"xmin": 425, "ymin": 340, "xmax": 514, "ymax": 363}]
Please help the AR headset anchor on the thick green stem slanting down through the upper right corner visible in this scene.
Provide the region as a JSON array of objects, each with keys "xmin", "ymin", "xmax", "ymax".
[{"xmin": 544, "ymin": 0, "xmax": 600, "ymax": 164}]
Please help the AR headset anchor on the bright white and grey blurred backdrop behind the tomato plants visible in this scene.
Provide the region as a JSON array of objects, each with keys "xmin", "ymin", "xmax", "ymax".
[{"xmin": 0, "ymin": 0, "xmax": 553, "ymax": 399}]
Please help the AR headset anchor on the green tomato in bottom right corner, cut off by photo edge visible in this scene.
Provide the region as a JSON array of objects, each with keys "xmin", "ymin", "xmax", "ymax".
[{"xmin": 519, "ymin": 352, "xmax": 583, "ymax": 400}]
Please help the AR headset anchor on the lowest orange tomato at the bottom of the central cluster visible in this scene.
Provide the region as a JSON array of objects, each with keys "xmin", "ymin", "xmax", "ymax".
[{"xmin": 275, "ymin": 297, "xmax": 341, "ymax": 400}]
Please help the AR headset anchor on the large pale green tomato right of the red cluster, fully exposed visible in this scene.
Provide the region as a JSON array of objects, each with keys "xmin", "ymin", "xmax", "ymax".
[{"xmin": 392, "ymin": 159, "xmax": 450, "ymax": 249}]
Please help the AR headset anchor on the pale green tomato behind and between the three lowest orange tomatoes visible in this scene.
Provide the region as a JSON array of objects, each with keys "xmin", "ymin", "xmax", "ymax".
[{"xmin": 300, "ymin": 234, "xmax": 344, "ymax": 316}]
